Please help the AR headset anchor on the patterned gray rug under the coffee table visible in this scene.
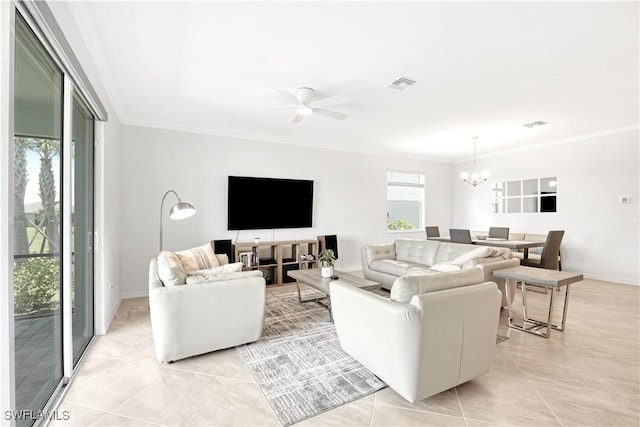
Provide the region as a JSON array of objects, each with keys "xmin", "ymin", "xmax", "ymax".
[{"xmin": 236, "ymin": 285, "xmax": 387, "ymax": 426}]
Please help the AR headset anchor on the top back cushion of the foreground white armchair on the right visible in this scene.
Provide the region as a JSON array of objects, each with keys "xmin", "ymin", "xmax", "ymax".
[{"xmin": 390, "ymin": 268, "xmax": 484, "ymax": 304}]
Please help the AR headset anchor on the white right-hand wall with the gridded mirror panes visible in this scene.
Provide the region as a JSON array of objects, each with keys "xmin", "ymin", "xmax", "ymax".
[{"xmin": 453, "ymin": 130, "xmax": 640, "ymax": 285}]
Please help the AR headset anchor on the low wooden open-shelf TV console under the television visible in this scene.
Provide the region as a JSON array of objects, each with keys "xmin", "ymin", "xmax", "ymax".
[{"xmin": 234, "ymin": 239, "xmax": 318, "ymax": 285}]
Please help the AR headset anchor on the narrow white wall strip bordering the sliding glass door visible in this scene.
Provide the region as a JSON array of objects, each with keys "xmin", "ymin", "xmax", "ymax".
[{"xmin": 48, "ymin": 2, "xmax": 121, "ymax": 334}]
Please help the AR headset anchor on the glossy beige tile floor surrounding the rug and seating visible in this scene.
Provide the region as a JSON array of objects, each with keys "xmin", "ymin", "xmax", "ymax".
[{"xmin": 52, "ymin": 280, "xmax": 640, "ymax": 426}]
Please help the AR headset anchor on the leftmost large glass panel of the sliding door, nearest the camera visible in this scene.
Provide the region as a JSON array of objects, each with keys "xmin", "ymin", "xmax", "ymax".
[{"xmin": 14, "ymin": 14, "xmax": 62, "ymax": 426}]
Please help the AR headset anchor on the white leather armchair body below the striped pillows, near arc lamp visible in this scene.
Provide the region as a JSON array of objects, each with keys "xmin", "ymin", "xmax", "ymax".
[{"xmin": 149, "ymin": 258, "xmax": 266, "ymax": 362}]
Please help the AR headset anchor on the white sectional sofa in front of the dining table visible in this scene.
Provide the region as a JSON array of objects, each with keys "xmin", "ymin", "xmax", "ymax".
[{"xmin": 361, "ymin": 239, "xmax": 520, "ymax": 307}]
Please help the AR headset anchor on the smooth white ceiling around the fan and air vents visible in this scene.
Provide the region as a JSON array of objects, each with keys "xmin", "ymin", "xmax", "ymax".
[{"xmin": 69, "ymin": 1, "xmax": 640, "ymax": 162}]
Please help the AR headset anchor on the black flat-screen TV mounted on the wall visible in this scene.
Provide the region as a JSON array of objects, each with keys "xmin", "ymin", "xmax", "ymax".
[{"xmin": 227, "ymin": 176, "xmax": 313, "ymax": 230}]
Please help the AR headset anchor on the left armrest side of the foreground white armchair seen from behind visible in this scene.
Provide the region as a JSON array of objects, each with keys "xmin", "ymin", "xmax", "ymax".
[{"xmin": 329, "ymin": 280, "xmax": 421, "ymax": 400}]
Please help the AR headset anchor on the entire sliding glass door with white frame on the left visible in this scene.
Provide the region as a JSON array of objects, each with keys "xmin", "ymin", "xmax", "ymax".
[{"xmin": 13, "ymin": 13, "xmax": 96, "ymax": 426}]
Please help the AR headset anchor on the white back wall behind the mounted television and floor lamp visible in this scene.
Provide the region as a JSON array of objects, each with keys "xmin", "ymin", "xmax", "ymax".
[{"xmin": 120, "ymin": 126, "xmax": 453, "ymax": 297}]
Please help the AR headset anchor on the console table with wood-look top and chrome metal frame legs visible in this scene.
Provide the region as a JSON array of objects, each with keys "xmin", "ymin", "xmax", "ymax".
[{"xmin": 493, "ymin": 266, "xmax": 583, "ymax": 338}]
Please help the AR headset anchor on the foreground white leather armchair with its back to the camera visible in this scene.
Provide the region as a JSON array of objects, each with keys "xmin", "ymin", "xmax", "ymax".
[{"xmin": 330, "ymin": 268, "xmax": 501, "ymax": 402}]
